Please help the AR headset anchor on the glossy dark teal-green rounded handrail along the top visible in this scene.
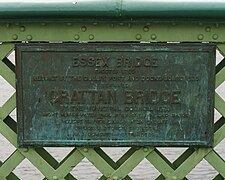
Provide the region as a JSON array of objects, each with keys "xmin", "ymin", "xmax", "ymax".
[{"xmin": 0, "ymin": 0, "xmax": 225, "ymax": 19}]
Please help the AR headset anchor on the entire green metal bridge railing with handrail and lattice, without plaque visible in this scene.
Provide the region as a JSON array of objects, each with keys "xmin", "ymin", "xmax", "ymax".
[{"xmin": 0, "ymin": 0, "xmax": 225, "ymax": 180}]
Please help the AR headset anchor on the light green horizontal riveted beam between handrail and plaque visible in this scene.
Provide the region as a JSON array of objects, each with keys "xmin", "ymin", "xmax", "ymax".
[{"xmin": 0, "ymin": 20, "xmax": 225, "ymax": 43}]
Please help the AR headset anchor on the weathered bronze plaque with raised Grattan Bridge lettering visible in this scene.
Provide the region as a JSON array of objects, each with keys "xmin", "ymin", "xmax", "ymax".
[{"xmin": 16, "ymin": 43, "xmax": 215, "ymax": 147}]
